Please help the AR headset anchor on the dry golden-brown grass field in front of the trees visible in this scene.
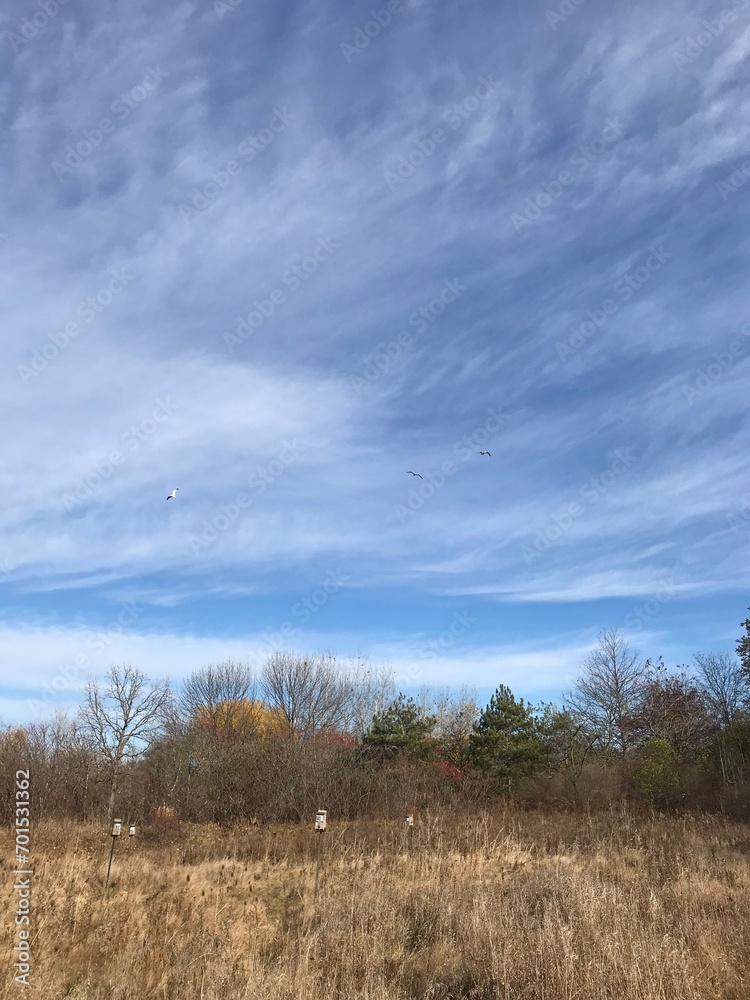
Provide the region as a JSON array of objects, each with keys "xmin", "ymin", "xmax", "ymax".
[{"xmin": 0, "ymin": 810, "xmax": 750, "ymax": 1000}]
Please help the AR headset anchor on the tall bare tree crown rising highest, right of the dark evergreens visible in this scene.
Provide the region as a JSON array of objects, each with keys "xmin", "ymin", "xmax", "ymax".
[{"xmin": 566, "ymin": 629, "xmax": 648, "ymax": 755}]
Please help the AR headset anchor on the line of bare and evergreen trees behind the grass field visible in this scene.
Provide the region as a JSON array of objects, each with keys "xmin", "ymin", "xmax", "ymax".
[{"xmin": 0, "ymin": 619, "xmax": 750, "ymax": 824}]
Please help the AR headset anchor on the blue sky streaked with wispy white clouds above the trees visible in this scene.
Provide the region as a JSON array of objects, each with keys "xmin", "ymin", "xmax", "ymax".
[{"xmin": 0, "ymin": 0, "xmax": 750, "ymax": 723}]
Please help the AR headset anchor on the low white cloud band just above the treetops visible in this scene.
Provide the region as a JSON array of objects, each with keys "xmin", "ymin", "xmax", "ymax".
[{"xmin": 0, "ymin": 603, "xmax": 604, "ymax": 721}]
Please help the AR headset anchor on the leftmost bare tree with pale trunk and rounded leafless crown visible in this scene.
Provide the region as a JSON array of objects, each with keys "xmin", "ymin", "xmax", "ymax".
[{"xmin": 79, "ymin": 664, "xmax": 170, "ymax": 819}]
